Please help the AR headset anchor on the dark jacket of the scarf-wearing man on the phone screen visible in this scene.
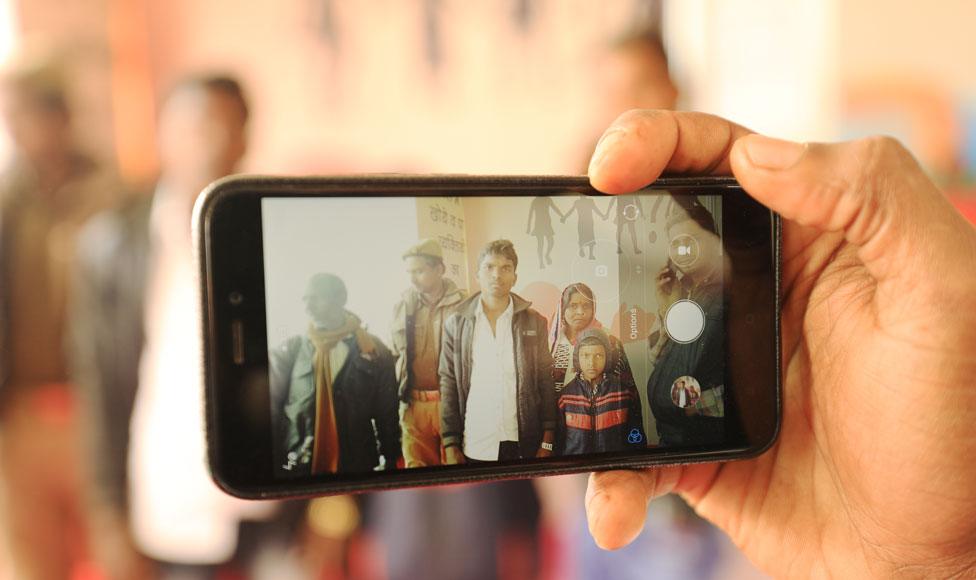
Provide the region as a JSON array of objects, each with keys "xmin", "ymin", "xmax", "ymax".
[{"xmin": 268, "ymin": 335, "xmax": 401, "ymax": 476}]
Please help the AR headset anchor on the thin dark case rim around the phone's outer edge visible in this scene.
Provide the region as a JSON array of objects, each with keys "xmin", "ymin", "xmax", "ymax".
[{"xmin": 193, "ymin": 173, "xmax": 782, "ymax": 499}]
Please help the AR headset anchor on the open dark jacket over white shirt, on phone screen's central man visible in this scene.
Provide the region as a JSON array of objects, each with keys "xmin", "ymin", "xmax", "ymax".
[{"xmin": 439, "ymin": 292, "xmax": 557, "ymax": 457}]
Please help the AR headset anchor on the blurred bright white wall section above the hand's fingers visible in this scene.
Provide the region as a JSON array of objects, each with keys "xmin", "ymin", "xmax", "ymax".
[{"xmin": 664, "ymin": 0, "xmax": 840, "ymax": 141}]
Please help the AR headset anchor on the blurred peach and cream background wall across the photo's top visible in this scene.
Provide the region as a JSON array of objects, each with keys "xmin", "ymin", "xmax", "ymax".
[{"xmin": 0, "ymin": 0, "xmax": 976, "ymax": 197}]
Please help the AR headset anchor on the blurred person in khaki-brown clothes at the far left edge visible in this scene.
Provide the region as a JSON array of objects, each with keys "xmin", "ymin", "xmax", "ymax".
[{"xmin": 0, "ymin": 54, "xmax": 120, "ymax": 579}]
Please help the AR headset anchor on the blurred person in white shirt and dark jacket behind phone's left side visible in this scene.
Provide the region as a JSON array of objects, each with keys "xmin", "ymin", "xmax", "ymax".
[{"xmin": 72, "ymin": 76, "xmax": 300, "ymax": 578}]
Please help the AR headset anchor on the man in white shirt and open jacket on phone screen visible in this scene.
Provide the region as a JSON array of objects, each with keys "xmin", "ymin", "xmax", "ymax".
[{"xmin": 440, "ymin": 240, "xmax": 556, "ymax": 464}]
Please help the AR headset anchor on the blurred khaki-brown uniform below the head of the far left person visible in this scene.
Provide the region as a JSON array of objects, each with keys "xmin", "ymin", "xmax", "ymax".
[{"xmin": 0, "ymin": 155, "xmax": 120, "ymax": 579}]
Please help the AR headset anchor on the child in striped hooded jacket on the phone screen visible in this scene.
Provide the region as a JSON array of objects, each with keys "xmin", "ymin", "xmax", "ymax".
[{"xmin": 558, "ymin": 328, "xmax": 644, "ymax": 455}]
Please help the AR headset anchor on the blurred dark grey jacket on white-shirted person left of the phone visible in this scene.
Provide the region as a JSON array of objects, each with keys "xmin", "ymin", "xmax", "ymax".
[{"xmin": 69, "ymin": 197, "xmax": 152, "ymax": 513}]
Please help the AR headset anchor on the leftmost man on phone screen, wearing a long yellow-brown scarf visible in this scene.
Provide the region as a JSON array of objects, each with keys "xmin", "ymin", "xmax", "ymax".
[{"xmin": 269, "ymin": 273, "xmax": 400, "ymax": 475}]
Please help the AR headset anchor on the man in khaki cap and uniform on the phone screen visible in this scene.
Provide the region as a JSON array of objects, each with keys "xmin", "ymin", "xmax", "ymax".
[{"xmin": 392, "ymin": 239, "xmax": 465, "ymax": 467}]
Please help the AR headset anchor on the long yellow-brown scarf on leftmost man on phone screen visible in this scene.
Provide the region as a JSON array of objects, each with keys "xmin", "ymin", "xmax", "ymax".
[{"xmin": 308, "ymin": 313, "xmax": 375, "ymax": 473}]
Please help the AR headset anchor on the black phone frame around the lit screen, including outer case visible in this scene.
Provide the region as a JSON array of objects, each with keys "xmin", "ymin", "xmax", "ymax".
[{"xmin": 194, "ymin": 174, "xmax": 781, "ymax": 499}]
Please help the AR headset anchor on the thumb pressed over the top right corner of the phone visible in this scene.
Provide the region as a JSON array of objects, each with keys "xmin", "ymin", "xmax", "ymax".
[{"xmin": 730, "ymin": 135, "xmax": 972, "ymax": 281}]
